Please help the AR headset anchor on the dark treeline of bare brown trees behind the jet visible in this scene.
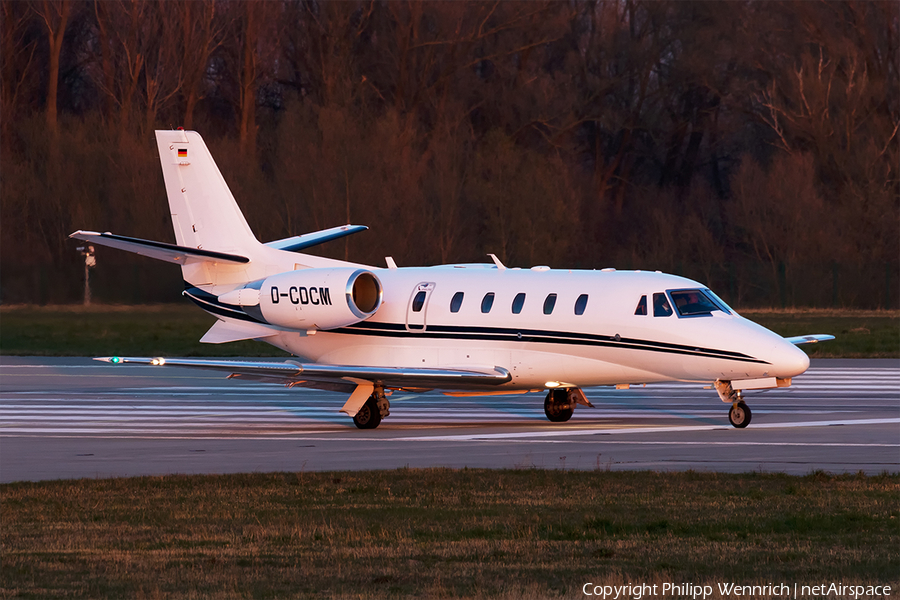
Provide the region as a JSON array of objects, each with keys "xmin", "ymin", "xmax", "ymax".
[{"xmin": 0, "ymin": 0, "xmax": 900, "ymax": 307}]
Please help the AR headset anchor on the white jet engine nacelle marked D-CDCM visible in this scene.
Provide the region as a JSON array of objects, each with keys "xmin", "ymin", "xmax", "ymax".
[{"xmin": 259, "ymin": 268, "xmax": 383, "ymax": 330}]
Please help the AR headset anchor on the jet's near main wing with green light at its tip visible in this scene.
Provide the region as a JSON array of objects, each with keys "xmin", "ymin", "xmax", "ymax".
[{"xmin": 94, "ymin": 356, "xmax": 512, "ymax": 391}]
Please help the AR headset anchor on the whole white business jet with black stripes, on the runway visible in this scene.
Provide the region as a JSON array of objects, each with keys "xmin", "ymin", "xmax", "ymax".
[{"xmin": 71, "ymin": 130, "xmax": 833, "ymax": 429}]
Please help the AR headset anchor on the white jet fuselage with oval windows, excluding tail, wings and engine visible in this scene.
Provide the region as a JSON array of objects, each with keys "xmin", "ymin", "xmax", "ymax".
[{"xmin": 227, "ymin": 265, "xmax": 809, "ymax": 389}]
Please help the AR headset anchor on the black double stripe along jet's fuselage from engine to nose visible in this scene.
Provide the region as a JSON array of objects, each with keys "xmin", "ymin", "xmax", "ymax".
[{"xmin": 331, "ymin": 321, "xmax": 769, "ymax": 364}]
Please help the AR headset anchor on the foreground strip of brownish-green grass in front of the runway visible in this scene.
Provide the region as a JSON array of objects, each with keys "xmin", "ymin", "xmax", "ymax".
[{"xmin": 0, "ymin": 469, "xmax": 900, "ymax": 598}]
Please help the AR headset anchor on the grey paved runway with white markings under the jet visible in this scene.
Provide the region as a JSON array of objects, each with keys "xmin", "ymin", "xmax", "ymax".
[{"xmin": 0, "ymin": 357, "xmax": 900, "ymax": 482}]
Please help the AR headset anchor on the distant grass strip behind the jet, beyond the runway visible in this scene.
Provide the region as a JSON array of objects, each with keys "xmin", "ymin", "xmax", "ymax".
[{"xmin": 0, "ymin": 304, "xmax": 900, "ymax": 358}]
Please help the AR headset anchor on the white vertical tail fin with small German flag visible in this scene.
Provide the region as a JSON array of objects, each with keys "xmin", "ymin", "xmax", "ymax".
[{"xmin": 156, "ymin": 130, "xmax": 260, "ymax": 255}]
